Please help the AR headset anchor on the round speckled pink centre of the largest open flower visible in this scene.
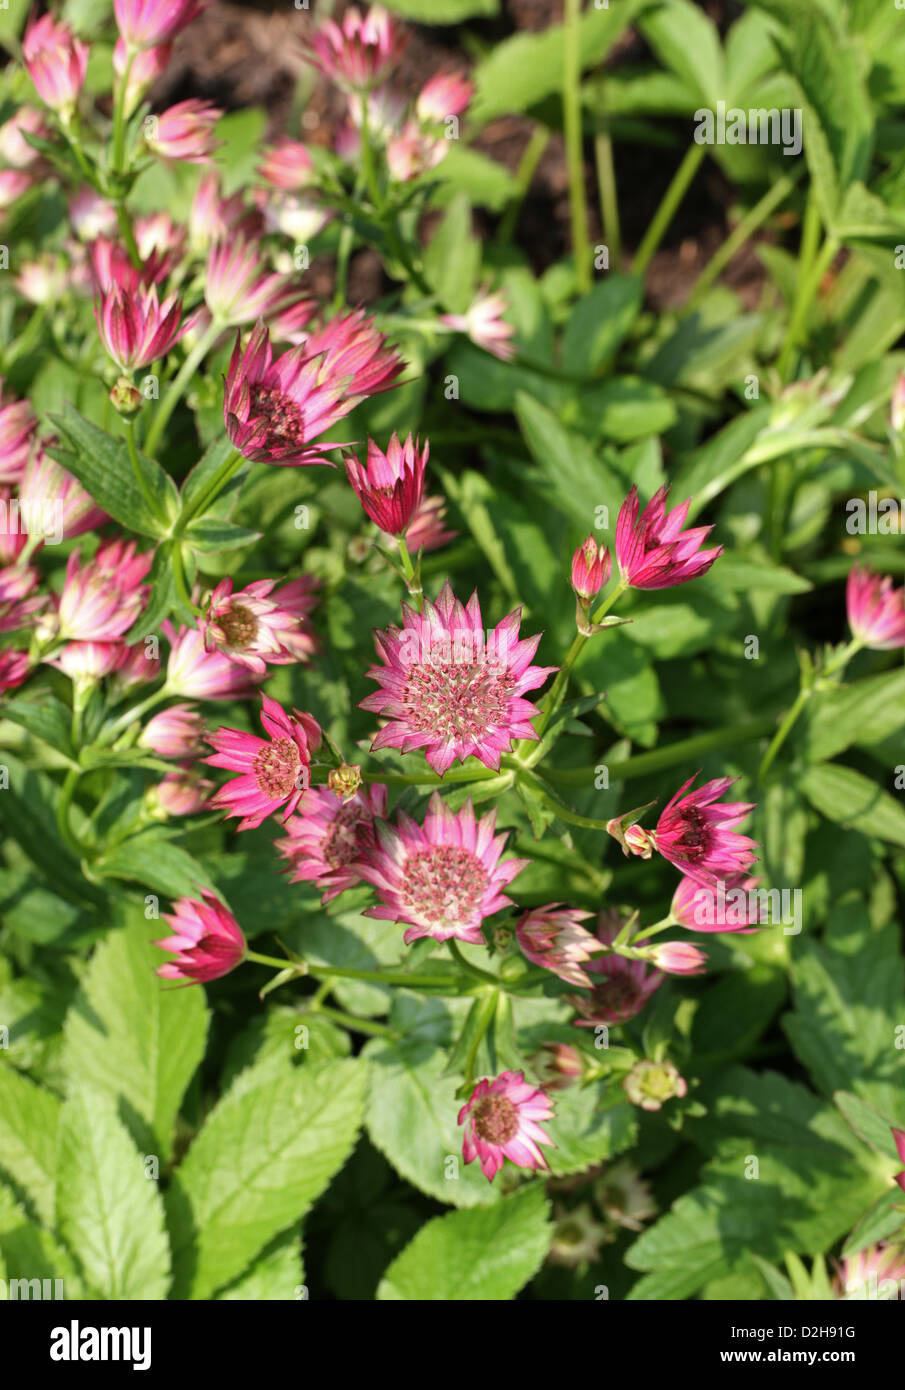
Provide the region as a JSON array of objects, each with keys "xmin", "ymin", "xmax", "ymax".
[{"xmin": 402, "ymin": 644, "xmax": 513, "ymax": 742}]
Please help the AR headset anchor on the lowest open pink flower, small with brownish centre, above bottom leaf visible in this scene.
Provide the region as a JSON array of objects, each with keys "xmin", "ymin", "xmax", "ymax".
[{"xmin": 459, "ymin": 1072, "xmax": 556, "ymax": 1183}]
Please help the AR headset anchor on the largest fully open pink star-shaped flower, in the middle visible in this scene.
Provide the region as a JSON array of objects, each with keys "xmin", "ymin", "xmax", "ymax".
[{"xmin": 360, "ymin": 581, "xmax": 556, "ymax": 776}]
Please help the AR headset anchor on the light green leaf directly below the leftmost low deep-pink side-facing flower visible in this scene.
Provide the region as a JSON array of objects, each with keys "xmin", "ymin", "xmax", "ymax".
[{"xmin": 63, "ymin": 917, "xmax": 207, "ymax": 1161}]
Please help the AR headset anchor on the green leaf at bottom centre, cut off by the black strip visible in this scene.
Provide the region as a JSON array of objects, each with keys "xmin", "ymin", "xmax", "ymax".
[{"xmin": 377, "ymin": 1183, "xmax": 552, "ymax": 1302}]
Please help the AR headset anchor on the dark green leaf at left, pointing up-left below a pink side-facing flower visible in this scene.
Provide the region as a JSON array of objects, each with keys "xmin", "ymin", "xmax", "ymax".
[{"xmin": 49, "ymin": 403, "xmax": 179, "ymax": 538}]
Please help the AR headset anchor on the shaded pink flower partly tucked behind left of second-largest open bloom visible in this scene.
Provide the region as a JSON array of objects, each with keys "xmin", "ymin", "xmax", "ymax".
[{"xmin": 277, "ymin": 785, "xmax": 386, "ymax": 902}]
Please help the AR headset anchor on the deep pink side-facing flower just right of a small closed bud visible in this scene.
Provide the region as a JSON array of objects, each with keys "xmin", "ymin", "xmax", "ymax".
[{"xmin": 616, "ymin": 482, "xmax": 723, "ymax": 589}]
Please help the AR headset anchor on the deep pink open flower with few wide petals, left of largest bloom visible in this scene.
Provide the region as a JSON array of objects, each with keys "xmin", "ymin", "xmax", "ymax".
[{"xmin": 204, "ymin": 695, "xmax": 321, "ymax": 830}]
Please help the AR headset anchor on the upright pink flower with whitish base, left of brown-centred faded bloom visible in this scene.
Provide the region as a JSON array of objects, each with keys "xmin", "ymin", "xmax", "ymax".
[{"xmin": 57, "ymin": 541, "xmax": 152, "ymax": 642}]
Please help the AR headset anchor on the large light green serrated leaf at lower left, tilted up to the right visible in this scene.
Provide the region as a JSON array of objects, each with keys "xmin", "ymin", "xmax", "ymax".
[{"xmin": 167, "ymin": 1058, "xmax": 364, "ymax": 1298}]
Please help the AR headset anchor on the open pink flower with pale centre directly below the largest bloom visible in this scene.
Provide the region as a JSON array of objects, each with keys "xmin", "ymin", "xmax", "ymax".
[{"xmin": 361, "ymin": 792, "xmax": 528, "ymax": 945}]
